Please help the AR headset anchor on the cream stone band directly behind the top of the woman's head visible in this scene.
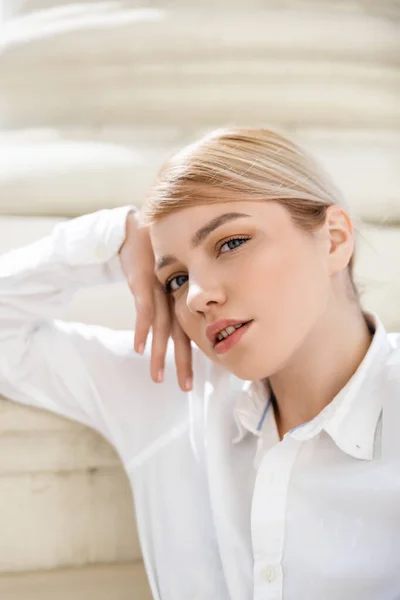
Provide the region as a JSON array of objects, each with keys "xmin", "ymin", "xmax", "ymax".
[{"xmin": 0, "ymin": 128, "xmax": 400, "ymax": 223}]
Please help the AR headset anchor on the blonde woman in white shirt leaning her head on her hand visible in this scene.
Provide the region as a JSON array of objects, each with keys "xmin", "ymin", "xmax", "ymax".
[{"xmin": 0, "ymin": 128, "xmax": 400, "ymax": 600}]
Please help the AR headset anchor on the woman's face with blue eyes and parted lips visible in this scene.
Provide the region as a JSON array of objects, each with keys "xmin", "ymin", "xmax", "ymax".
[{"xmin": 150, "ymin": 201, "xmax": 331, "ymax": 380}]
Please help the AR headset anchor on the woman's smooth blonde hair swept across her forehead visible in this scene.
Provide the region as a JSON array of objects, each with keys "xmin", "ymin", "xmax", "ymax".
[{"xmin": 141, "ymin": 127, "xmax": 358, "ymax": 297}]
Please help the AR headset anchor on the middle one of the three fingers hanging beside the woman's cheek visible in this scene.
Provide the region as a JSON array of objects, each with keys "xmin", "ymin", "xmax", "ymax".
[{"xmin": 150, "ymin": 284, "xmax": 171, "ymax": 383}]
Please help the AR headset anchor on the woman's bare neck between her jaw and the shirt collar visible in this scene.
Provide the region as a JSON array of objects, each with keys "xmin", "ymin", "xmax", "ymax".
[{"xmin": 269, "ymin": 305, "xmax": 372, "ymax": 439}]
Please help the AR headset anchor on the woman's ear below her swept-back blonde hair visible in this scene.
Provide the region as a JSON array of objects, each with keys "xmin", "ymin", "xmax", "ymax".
[{"xmin": 325, "ymin": 204, "xmax": 354, "ymax": 275}]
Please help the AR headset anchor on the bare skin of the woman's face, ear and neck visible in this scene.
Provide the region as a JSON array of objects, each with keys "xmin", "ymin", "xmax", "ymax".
[{"xmin": 119, "ymin": 202, "xmax": 371, "ymax": 438}]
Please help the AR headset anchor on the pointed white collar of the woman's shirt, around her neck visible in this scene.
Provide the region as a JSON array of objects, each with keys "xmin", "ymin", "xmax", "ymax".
[{"xmin": 232, "ymin": 312, "xmax": 391, "ymax": 460}]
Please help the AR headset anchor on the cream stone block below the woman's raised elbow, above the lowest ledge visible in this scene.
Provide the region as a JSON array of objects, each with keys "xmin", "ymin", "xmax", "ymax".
[{"xmin": 0, "ymin": 396, "xmax": 141, "ymax": 572}]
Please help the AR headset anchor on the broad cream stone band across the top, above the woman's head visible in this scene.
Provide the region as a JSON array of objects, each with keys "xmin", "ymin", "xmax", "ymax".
[{"xmin": 0, "ymin": 2, "xmax": 400, "ymax": 128}]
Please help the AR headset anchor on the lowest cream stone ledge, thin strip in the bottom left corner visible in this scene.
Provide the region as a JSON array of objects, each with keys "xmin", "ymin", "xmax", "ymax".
[{"xmin": 0, "ymin": 562, "xmax": 152, "ymax": 600}]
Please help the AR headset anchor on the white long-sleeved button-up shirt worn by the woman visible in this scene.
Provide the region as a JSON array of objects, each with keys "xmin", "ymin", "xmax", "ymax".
[{"xmin": 0, "ymin": 206, "xmax": 400, "ymax": 600}]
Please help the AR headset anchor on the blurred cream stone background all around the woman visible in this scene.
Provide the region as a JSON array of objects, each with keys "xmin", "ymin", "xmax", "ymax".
[{"xmin": 0, "ymin": 0, "xmax": 400, "ymax": 600}]
